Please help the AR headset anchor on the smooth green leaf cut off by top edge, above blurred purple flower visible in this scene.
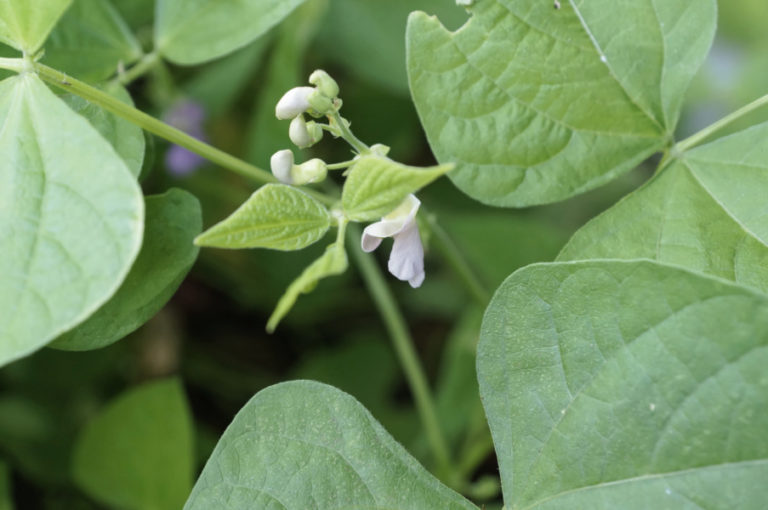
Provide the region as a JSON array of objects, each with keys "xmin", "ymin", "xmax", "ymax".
[{"xmin": 155, "ymin": 0, "xmax": 305, "ymax": 65}]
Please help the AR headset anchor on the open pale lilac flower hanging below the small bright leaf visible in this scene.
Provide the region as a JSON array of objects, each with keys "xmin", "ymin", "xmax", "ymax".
[{"xmin": 360, "ymin": 195, "xmax": 424, "ymax": 288}]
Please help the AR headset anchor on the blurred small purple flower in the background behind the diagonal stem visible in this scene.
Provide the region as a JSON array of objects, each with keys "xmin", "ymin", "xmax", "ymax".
[{"xmin": 164, "ymin": 99, "xmax": 206, "ymax": 177}]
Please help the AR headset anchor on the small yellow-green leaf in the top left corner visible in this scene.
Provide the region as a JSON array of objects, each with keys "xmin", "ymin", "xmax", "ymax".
[{"xmin": 0, "ymin": 0, "xmax": 72, "ymax": 55}]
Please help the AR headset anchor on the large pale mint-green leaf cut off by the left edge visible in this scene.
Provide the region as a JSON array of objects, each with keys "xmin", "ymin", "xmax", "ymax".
[{"xmin": 0, "ymin": 74, "xmax": 144, "ymax": 365}]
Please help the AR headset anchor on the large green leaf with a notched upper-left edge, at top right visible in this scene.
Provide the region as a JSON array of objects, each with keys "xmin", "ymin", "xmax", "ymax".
[{"xmin": 407, "ymin": 0, "xmax": 716, "ymax": 207}]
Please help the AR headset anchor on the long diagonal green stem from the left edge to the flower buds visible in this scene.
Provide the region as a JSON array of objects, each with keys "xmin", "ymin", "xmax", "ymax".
[{"xmin": 0, "ymin": 58, "xmax": 336, "ymax": 205}]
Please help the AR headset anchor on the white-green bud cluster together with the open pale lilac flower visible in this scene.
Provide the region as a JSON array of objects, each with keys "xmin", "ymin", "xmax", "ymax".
[{"xmin": 270, "ymin": 70, "xmax": 424, "ymax": 288}]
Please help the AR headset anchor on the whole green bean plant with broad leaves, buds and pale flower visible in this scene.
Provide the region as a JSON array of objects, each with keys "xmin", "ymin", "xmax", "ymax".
[{"xmin": 0, "ymin": 0, "xmax": 768, "ymax": 510}]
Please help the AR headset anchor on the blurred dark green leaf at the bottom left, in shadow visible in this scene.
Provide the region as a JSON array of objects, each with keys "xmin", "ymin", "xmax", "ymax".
[{"xmin": 72, "ymin": 379, "xmax": 194, "ymax": 510}]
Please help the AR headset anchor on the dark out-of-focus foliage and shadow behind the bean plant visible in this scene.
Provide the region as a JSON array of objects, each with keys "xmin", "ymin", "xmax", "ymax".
[{"xmin": 0, "ymin": 0, "xmax": 768, "ymax": 510}]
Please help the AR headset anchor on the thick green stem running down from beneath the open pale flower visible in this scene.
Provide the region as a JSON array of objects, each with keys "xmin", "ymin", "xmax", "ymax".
[{"xmin": 348, "ymin": 225, "xmax": 452, "ymax": 479}]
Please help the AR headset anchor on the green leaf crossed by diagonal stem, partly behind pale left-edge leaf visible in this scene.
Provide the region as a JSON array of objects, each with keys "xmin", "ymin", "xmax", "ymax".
[{"xmin": 62, "ymin": 84, "xmax": 147, "ymax": 177}]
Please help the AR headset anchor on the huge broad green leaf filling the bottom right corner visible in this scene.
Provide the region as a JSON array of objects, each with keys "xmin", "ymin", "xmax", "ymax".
[{"xmin": 478, "ymin": 260, "xmax": 768, "ymax": 510}]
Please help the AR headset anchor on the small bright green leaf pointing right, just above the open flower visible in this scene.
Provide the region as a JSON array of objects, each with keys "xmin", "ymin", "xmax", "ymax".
[{"xmin": 341, "ymin": 156, "xmax": 453, "ymax": 221}]
